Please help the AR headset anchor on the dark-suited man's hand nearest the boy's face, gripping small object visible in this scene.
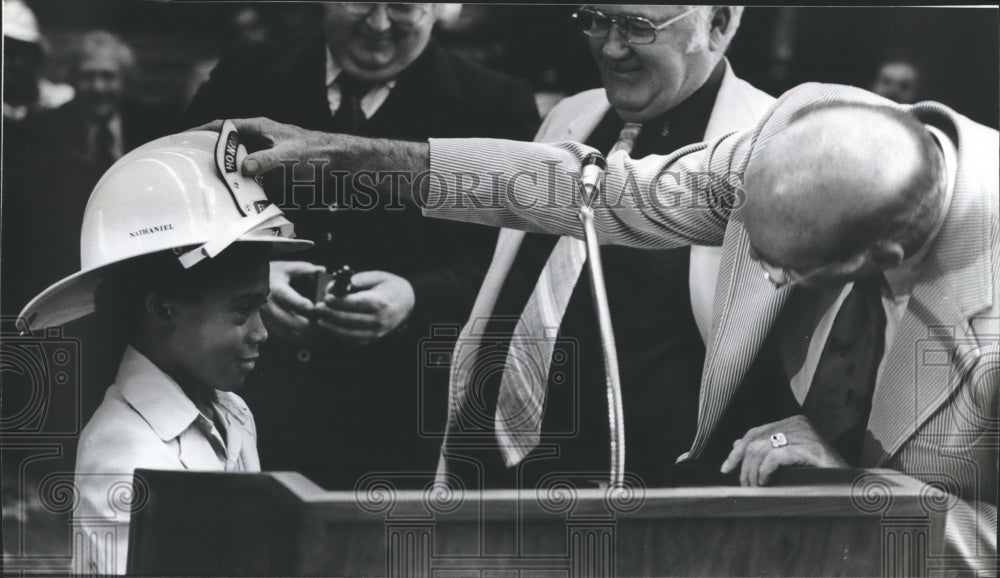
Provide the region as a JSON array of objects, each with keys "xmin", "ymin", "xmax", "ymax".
[{"xmin": 261, "ymin": 261, "xmax": 324, "ymax": 343}]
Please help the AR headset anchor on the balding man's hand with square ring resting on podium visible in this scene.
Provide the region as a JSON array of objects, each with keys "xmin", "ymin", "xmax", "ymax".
[{"xmin": 722, "ymin": 415, "xmax": 849, "ymax": 486}]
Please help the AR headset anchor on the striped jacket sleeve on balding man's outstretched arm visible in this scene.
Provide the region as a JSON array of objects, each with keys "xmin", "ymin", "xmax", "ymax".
[{"xmin": 424, "ymin": 128, "xmax": 750, "ymax": 249}]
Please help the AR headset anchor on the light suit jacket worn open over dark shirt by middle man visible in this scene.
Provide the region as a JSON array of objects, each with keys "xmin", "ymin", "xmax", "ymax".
[{"xmin": 470, "ymin": 60, "xmax": 774, "ymax": 343}]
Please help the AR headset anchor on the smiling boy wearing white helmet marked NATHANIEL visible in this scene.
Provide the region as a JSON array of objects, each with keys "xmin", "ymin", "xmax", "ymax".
[{"xmin": 21, "ymin": 123, "xmax": 311, "ymax": 574}]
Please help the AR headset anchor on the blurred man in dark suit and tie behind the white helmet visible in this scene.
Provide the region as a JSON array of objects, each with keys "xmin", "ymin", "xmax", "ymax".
[{"xmin": 3, "ymin": 30, "xmax": 173, "ymax": 320}]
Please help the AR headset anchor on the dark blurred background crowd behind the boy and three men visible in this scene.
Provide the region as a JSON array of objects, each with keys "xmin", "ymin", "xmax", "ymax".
[{"xmin": 0, "ymin": 0, "xmax": 1000, "ymax": 572}]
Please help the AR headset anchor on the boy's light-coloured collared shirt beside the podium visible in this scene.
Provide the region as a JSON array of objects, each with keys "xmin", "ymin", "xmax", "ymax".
[{"xmin": 73, "ymin": 347, "xmax": 260, "ymax": 575}]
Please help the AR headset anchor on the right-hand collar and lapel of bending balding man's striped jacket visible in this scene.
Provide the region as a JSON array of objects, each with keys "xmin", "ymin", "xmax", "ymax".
[{"xmin": 862, "ymin": 103, "xmax": 997, "ymax": 465}]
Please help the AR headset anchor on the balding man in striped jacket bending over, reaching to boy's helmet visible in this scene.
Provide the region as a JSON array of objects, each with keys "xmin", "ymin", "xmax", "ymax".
[{"xmin": 207, "ymin": 84, "xmax": 1000, "ymax": 572}]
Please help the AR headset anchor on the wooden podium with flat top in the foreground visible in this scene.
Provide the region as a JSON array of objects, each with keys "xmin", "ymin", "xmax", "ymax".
[{"xmin": 128, "ymin": 470, "xmax": 943, "ymax": 577}]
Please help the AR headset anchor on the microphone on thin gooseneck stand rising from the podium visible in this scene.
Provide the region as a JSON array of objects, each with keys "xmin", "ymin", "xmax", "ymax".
[{"xmin": 578, "ymin": 154, "xmax": 625, "ymax": 488}]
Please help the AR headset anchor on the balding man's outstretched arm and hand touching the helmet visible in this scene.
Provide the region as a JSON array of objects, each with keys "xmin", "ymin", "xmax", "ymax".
[{"xmin": 236, "ymin": 118, "xmax": 753, "ymax": 249}]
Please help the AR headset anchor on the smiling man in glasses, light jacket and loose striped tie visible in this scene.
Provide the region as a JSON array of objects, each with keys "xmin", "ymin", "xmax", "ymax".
[{"xmin": 445, "ymin": 5, "xmax": 774, "ymax": 487}]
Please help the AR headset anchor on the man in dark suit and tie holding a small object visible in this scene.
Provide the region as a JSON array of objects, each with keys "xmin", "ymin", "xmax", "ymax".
[{"xmin": 185, "ymin": 3, "xmax": 538, "ymax": 488}]
